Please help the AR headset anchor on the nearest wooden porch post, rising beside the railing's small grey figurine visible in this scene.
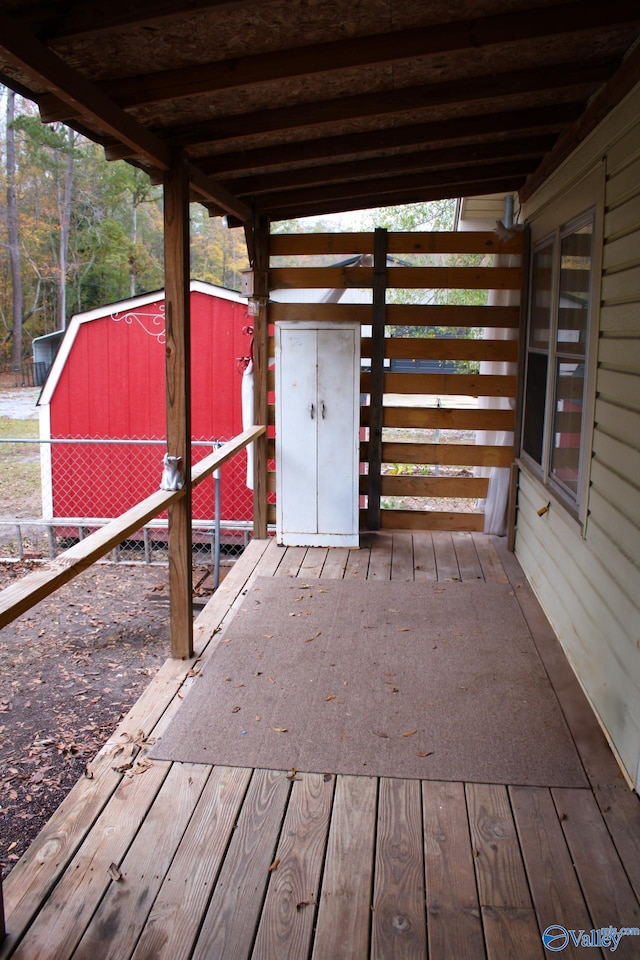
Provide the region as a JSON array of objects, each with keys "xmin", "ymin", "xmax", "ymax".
[{"xmin": 164, "ymin": 153, "xmax": 193, "ymax": 659}]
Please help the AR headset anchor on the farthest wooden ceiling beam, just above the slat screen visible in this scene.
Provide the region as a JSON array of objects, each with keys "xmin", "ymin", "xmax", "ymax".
[{"xmin": 262, "ymin": 176, "xmax": 524, "ymax": 226}]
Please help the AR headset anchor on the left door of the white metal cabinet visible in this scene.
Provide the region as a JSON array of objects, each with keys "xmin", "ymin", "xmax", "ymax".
[{"xmin": 276, "ymin": 325, "xmax": 318, "ymax": 536}]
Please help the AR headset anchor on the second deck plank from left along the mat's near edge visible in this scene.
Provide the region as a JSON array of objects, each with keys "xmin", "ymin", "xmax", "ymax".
[{"xmin": 74, "ymin": 763, "xmax": 211, "ymax": 960}]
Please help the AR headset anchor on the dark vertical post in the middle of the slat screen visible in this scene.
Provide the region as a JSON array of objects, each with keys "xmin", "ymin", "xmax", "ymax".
[{"xmin": 367, "ymin": 228, "xmax": 387, "ymax": 530}]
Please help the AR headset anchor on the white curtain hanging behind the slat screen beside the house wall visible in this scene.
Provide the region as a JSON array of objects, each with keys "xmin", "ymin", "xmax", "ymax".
[{"xmin": 475, "ymin": 256, "xmax": 520, "ymax": 537}]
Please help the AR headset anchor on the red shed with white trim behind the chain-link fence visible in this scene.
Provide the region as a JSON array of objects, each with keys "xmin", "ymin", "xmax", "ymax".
[{"xmin": 39, "ymin": 281, "xmax": 252, "ymax": 521}]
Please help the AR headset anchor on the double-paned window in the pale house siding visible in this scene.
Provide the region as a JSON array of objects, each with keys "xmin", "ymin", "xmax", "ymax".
[{"xmin": 522, "ymin": 212, "xmax": 594, "ymax": 509}]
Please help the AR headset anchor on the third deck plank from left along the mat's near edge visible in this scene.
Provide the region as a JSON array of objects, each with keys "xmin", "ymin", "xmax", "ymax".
[{"xmin": 133, "ymin": 767, "xmax": 251, "ymax": 960}]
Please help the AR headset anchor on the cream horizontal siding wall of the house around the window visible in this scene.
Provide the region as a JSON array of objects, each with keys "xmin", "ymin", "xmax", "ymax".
[{"xmin": 516, "ymin": 85, "xmax": 640, "ymax": 789}]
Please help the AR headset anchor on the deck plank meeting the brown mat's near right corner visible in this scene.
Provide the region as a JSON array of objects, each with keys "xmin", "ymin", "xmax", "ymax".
[{"xmin": 552, "ymin": 788, "xmax": 640, "ymax": 944}]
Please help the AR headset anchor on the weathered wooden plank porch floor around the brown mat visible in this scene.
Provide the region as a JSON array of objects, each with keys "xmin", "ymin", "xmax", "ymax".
[{"xmin": 0, "ymin": 533, "xmax": 640, "ymax": 960}]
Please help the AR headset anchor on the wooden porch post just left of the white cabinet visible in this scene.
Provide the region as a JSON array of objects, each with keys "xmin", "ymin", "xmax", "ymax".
[{"xmin": 252, "ymin": 217, "xmax": 269, "ymax": 540}]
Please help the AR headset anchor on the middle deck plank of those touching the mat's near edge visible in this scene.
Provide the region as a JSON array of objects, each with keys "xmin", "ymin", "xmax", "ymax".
[{"xmin": 312, "ymin": 776, "xmax": 377, "ymax": 960}]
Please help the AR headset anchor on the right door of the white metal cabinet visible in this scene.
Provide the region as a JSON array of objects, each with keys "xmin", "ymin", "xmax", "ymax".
[{"xmin": 317, "ymin": 328, "xmax": 359, "ymax": 535}]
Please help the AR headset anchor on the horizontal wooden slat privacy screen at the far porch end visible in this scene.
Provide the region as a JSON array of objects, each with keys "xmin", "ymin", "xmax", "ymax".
[{"xmin": 267, "ymin": 232, "xmax": 523, "ymax": 531}]
